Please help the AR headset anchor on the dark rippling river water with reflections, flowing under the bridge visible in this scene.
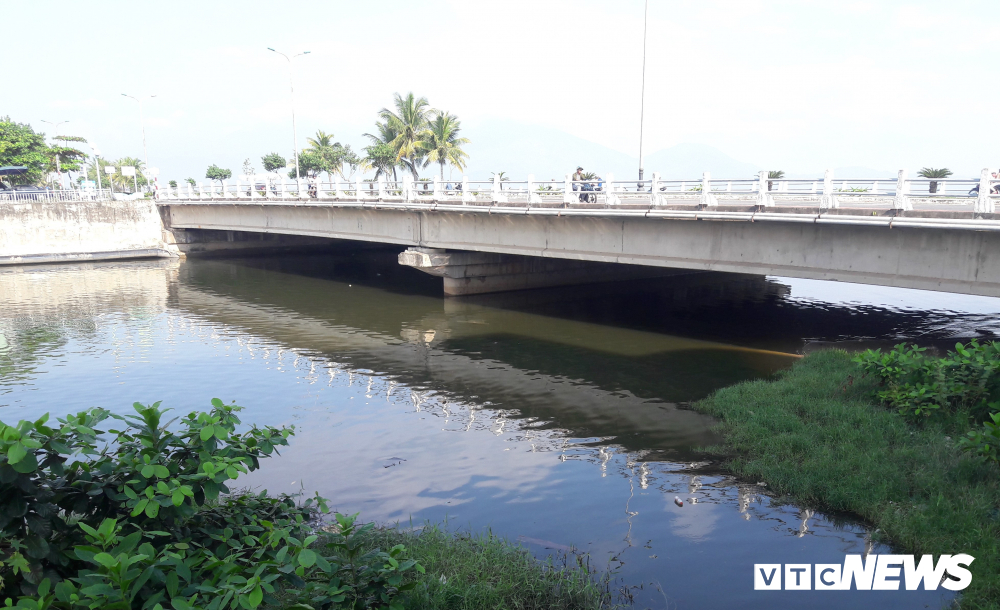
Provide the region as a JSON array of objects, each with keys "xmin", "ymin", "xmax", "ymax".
[{"xmin": 0, "ymin": 251, "xmax": 1000, "ymax": 609}]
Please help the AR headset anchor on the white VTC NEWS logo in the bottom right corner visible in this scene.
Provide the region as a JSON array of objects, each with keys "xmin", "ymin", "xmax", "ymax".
[{"xmin": 753, "ymin": 554, "xmax": 975, "ymax": 591}]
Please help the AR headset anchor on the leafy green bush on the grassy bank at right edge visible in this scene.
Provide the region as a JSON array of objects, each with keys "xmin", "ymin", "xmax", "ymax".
[{"xmin": 855, "ymin": 340, "xmax": 1000, "ymax": 422}]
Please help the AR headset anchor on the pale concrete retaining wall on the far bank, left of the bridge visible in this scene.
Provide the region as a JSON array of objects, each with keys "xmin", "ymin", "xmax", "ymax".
[{"xmin": 0, "ymin": 200, "xmax": 177, "ymax": 265}]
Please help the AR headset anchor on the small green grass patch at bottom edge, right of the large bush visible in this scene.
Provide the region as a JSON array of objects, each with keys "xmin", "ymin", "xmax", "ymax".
[{"xmin": 346, "ymin": 526, "xmax": 612, "ymax": 610}]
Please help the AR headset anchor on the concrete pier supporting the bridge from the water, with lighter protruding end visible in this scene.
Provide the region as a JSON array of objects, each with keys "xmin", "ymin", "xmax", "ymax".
[{"xmin": 399, "ymin": 248, "xmax": 699, "ymax": 296}]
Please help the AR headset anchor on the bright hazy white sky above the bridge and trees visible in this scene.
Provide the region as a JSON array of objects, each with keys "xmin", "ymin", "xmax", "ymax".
[{"xmin": 0, "ymin": 0, "xmax": 1000, "ymax": 179}]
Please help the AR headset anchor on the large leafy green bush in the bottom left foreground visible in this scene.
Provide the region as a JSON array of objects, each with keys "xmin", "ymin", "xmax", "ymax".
[{"xmin": 0, "ymin": 399, "xmax": 422, "ymax": 610}]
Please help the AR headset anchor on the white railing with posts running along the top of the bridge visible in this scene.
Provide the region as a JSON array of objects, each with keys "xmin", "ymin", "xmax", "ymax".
[{"xmin": 157, "ymin": 170, "xmax": 1000, "ymax": 213}]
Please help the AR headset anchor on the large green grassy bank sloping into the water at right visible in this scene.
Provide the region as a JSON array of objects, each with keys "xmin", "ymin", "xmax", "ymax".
[{"xmin": 695, "ymin": 350, "xmax": 1000, "ymax": 608}]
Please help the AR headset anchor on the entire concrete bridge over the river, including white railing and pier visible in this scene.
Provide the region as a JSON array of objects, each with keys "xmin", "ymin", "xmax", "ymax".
[{"xmin": 159, "ymin": 171, "xmax": 1000, "ymax": 296}]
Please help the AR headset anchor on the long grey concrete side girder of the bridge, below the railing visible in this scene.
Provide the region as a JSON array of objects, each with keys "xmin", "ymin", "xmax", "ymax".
[{"xmin": 163, "ymin": 203, "xmax": 1000, "ymax": 296}]
